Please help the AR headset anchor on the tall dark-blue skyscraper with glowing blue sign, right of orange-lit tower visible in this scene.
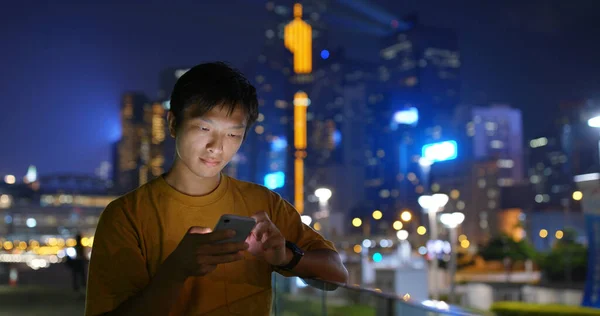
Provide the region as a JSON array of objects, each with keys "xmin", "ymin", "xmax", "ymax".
[{"xmin": 356, "ymin": 21, "xmax": 460, "ymax": 220}]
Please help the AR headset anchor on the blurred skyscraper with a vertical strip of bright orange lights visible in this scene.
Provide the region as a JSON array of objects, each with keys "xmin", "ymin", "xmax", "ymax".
[{"xmin": 236, "ymin": 1, "xmax": 374, "ymax": 225}]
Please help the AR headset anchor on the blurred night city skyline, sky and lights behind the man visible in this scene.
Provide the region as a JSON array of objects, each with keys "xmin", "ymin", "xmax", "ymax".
[{"xmin": 0, "ymin": 0, "xmax": 600, "ymax": 315}]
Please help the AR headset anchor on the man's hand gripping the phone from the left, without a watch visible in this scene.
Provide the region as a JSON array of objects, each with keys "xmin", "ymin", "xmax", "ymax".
[{"xmin": 165, "ymin": 226, "xmax": 248, "ymax": 280}]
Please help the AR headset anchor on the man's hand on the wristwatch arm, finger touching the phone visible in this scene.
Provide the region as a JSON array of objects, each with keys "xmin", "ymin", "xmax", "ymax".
[{"xmin": 246, "ymin": 211, "xmax": 288, "ymax": 266}]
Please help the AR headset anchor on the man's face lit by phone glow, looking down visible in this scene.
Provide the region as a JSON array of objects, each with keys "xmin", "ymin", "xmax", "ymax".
[{"xmin": 171, "ymin": 106, "xmax": 246, "ymax": 178}]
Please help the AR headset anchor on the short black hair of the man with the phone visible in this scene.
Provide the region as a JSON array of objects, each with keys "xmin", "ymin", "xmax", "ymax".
[{"xmin": 170, "ymin": 62, "xmax": 258, "ymax": 131}]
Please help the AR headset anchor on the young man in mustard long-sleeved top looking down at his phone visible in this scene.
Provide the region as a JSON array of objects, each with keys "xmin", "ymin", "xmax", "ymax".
[{"xmin": 86, "ymin": 63, "xmax": 348, "ymax": 315}]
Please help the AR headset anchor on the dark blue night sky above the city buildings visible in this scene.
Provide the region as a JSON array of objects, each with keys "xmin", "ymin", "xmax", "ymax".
[{"xmin": 0, "ymin": 0, "xmax": 600, "ymax": 177}]
